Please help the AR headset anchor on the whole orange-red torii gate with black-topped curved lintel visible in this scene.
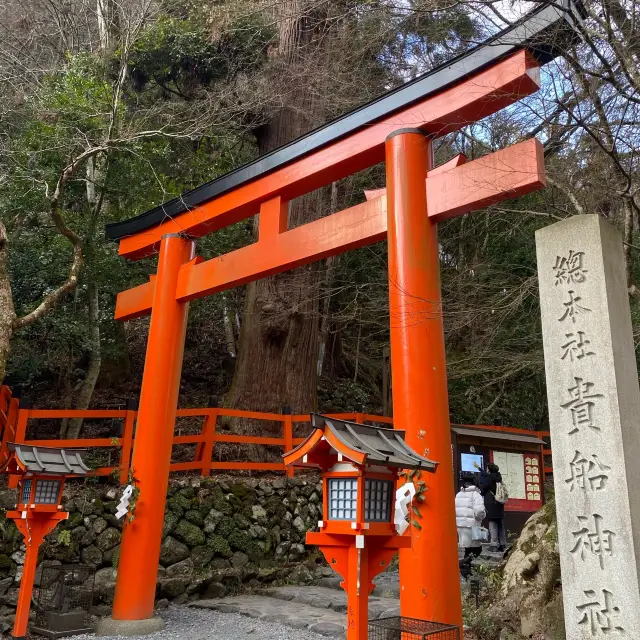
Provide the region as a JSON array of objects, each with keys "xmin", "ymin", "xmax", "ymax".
[{"xmin": 107, "ymin": 5, "xmax": 580, "ymax": 626}]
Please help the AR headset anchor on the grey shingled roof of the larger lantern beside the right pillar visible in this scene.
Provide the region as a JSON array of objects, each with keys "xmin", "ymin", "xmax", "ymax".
[{"xmin": 284, "ymin": 413, "xmax": 438, "ymax": 473}]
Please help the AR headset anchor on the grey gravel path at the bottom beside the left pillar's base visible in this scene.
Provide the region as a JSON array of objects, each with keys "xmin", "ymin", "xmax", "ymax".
[{"xmin": 74, "ymin": 607, "xmax": 327, "ymax": 640}]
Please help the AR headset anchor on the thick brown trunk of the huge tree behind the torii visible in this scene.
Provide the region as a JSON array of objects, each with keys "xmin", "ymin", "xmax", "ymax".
[{"xmin": 229, "ymin": 0, "xmax": 329, "ymax": 428}]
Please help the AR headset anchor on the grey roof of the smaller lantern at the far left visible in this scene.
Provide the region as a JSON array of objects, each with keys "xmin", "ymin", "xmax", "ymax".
[{"xmin": 1, "ymin": 442, "xmax": 90, "ymax": 476}]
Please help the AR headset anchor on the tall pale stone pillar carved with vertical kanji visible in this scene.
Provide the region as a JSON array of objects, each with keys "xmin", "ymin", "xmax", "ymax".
[{"xmin": 536, "ymin": 215, "xmax": 640, "ymax": 640}]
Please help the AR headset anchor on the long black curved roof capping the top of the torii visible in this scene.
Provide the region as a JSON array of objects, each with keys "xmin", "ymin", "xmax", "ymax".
[{"xmin": 106, "ymin": 0, "xmax": 583, "ymax": 240}]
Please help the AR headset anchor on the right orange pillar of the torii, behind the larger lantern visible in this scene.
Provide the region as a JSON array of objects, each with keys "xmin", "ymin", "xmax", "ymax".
[{"xmin": 386, "ymin": 129, "xmax": 462, "ymax": 629}]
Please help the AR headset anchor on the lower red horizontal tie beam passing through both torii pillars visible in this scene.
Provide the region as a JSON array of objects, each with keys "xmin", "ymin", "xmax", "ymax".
[{"xmin": 115, "ymin": 140, "xmax": 545, "ymax": 320}]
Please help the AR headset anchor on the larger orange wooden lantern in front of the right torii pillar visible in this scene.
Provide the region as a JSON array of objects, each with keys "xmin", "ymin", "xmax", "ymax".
[{"xmin": 284, "ymin": 414, "xmax": 437, "ymax": 640}]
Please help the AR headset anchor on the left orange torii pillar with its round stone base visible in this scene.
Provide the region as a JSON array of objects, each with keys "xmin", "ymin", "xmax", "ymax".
[{"xmin": 110, "ymin": 233, "xmax": 195, "ymax": 635}]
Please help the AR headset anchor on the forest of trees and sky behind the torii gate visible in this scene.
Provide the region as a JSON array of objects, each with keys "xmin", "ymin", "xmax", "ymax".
[{"xmin": 0, "ymin": 0, "xmax": 640, "ymax": 436}]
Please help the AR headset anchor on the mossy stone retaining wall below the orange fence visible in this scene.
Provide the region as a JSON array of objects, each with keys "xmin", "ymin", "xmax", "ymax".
[{"xmin": 0, "ymin": 477, "xmax": 322, "ymax": 633}]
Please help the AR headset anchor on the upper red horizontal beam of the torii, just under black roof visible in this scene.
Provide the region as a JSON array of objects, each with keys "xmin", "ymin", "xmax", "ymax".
[{"xmin": 120, "ymin": 50, "xmax": 540, "ymax": 260}]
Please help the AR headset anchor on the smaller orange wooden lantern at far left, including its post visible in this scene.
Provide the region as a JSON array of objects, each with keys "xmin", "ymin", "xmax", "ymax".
[{"xmin": 0, "ymin": 442, "xmax": 89, "ymax": 638}]
